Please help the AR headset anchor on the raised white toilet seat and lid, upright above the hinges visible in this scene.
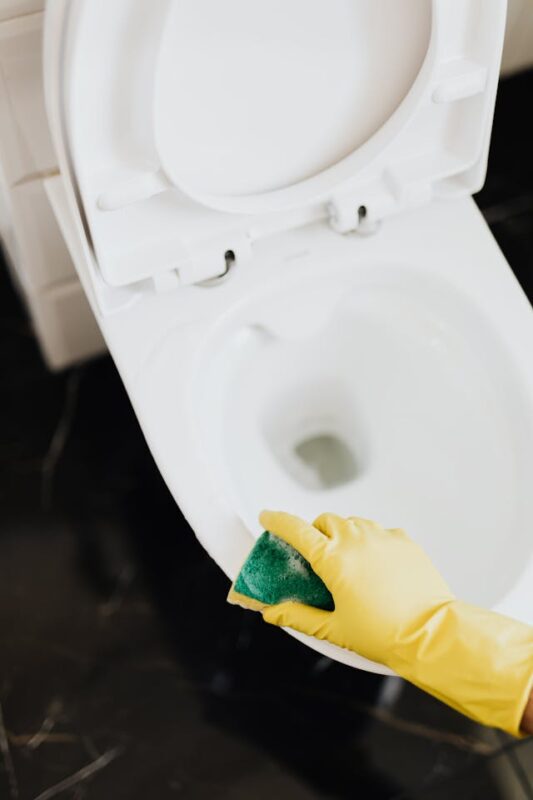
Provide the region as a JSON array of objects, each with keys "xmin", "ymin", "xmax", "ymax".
[{"xmin": 45, "ymin": 0, "xmax": 506, "ymax": 300}]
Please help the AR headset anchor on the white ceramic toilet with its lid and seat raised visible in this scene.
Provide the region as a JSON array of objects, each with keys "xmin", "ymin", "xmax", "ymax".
[{"xmin": 7, "ymin": 0, "xmax": 533, "ymax": 673}]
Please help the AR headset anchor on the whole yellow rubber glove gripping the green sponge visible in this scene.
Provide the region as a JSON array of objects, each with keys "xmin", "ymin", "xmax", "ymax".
[{"xmin": 260, "ymin": 511, "xmax": 533, "ymax": 736}]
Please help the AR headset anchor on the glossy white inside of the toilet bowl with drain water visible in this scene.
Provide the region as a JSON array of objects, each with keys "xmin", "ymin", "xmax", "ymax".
[{"xmin": 192, "ymin": 265, "xmax": 533, "ymax": 606}]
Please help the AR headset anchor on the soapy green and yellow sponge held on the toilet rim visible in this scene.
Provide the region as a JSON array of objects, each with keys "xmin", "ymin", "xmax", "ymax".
[{"xmin": 228, "ymin": 531, "xmax": 335, "ymax": 611}]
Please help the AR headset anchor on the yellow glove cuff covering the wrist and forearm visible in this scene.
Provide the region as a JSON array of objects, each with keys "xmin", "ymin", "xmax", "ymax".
[{"xmin": 388, "ymin": 600, "xmax": 533, "ymax": 736}]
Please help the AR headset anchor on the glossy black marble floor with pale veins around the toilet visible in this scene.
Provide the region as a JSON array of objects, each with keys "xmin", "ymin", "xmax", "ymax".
[{"xmin": 0, "ymin": 70, "xmax": 533, "ymax": 800}]
